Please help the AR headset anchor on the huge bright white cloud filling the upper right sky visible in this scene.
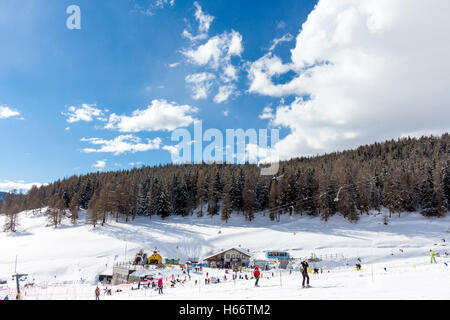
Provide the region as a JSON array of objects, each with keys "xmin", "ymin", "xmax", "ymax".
[{"xmin": 249, "ymin": 0, "xmax": 450, "ymax": 158}]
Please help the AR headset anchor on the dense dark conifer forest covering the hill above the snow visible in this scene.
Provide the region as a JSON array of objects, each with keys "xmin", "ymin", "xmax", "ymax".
[{"xmin": 1, "ymin": 133, "xmax": 450, "ymax": 230}]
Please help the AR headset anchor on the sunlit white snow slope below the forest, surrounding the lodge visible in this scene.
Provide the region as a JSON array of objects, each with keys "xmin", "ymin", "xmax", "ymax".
[{"xmin": 0, "ymin": 212, "xmax": 450, "ymax": 299}]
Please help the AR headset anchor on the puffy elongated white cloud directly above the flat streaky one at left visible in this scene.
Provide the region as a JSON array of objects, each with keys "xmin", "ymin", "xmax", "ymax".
[{"xmin": 105, "ymin": 99, "xmax": 198, "ymax": 132}]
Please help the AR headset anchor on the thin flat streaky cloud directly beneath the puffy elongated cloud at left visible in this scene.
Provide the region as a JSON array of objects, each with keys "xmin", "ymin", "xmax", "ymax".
[{"xmin": 81, "ymin": 134, "xmax": 161, "ymax": 156}]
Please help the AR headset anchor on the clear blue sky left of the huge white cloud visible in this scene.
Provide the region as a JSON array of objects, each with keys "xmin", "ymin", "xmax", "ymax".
[{"xmin": 0, "ymin": 0, "xmax": 314, "ymax": 188}]
